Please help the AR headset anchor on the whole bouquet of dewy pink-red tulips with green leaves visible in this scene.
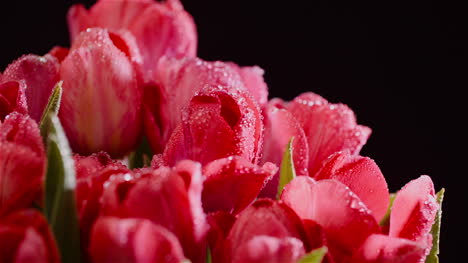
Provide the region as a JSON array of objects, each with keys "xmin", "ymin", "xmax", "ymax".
[{"xmin": 0, "ymin": 0, "xmax": 444, "ymax": 263}]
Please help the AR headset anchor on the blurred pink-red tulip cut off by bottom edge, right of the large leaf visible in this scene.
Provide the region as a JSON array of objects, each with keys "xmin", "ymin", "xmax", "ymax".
[{"xmin": 89, "ymin": 217, "xmax": 185, "ymax": 263}]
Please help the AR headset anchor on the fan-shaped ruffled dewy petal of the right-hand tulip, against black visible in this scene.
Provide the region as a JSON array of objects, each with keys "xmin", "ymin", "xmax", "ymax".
[{"xmin": 287, "ymin": 92, "xmax": 371, "ymax": 176}]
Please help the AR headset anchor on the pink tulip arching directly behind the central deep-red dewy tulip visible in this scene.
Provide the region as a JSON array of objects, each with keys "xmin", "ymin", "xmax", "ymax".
[{"xmin": 144, "ymin": 57, "xmax": 268, "ymax": 153}]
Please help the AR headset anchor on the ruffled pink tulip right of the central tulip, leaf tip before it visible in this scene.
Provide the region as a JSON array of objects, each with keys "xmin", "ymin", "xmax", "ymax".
[{"xmin": 263, "ymin": 92, "xmax": 371, "ymax": 182}]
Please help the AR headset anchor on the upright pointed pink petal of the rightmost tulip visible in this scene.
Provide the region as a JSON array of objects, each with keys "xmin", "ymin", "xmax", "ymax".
[{"xmin": 389, "ymin": 175, "xmax": 439, "ymax": 242}]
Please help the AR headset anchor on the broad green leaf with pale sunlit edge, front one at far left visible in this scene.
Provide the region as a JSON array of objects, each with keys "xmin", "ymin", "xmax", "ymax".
[{"xmin": 44, "ymin": 115, "xmax": 81, "ymax": 263}]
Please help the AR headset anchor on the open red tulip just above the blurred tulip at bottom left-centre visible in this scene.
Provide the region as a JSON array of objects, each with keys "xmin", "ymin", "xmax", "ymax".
[{"xmin": 101, "ymin": 161, "xmax": 208, "ymax": 262}]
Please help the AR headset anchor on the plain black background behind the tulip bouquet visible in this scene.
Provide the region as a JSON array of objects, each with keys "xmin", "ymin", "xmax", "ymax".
[{"xmin": 0, "ymin": 0, "xmax": 462, "ymax": 263}]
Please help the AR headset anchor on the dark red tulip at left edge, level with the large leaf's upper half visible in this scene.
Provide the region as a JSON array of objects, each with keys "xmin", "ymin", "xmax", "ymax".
[{"xmin": 0, "ymin": 112, "xmax": 45, "ymax": 215}]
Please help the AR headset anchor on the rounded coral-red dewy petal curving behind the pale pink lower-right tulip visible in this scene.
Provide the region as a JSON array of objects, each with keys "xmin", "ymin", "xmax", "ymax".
[{"xmin": 315, "ymin": 151, "xmax": 390, "ymax": 222}]
